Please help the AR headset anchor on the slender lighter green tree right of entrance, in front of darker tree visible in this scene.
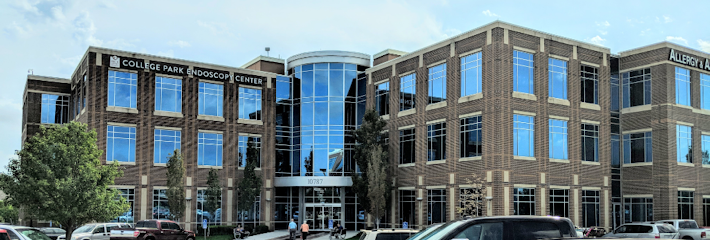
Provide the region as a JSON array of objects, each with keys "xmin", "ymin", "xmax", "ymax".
[{"xmin": 367, "ymin": 145, "xmax": 389, "ymax": 229}]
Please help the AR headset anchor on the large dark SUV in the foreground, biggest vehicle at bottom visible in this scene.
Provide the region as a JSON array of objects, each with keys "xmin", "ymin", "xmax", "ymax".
[{"xmin": 421, "ymin": 216, "xmax": 577, "ymax": 240}]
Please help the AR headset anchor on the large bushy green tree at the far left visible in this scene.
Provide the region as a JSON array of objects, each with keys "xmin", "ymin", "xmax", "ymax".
[{"xmin": 0, "ymin": 122, "xmax": 129, "ymax": 239}]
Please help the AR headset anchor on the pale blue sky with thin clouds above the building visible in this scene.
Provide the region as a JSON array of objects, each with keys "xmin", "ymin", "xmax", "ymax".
[{"xmin": 0, "ymin": 0, "xmax": 710, "ymax": 171}]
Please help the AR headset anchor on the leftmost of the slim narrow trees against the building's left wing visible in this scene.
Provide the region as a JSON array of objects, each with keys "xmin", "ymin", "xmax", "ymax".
[{"xmin": 165, "ymin": 149, "xmax": 187, "ymax": 221}]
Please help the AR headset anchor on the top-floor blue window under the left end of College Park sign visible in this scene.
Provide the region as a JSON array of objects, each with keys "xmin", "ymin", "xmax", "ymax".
[{"xmin": 108, "ymin": 71, "xmax": 138, "ymax": 108}]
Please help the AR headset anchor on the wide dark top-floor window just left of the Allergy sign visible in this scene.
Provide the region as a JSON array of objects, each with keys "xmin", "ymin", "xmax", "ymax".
[{"xmin": 621, "ymin": 68, "xmax": 651, "ymax": 108}]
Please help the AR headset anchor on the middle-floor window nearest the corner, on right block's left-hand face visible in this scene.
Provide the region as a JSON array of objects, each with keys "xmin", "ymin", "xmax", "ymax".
[{"xmin": 459, "ymin": 116, "xmax": 483, "ymax": 158}]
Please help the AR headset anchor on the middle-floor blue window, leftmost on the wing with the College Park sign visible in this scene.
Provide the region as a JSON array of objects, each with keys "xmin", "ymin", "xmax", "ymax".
[{"xmin": 106, "ymin": 125, "xmax": 136, "ymax": 162}]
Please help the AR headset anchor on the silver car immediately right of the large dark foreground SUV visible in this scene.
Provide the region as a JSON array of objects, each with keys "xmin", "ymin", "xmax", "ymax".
[{"xmin": 604, "ymin": 223, "xmax": 678, "ymax": 239}]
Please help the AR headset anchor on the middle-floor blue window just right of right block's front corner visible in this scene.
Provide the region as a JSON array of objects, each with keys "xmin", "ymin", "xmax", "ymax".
[{"xmin": 513, "ymin": 115, "xmax": 535, "ymax": 157}]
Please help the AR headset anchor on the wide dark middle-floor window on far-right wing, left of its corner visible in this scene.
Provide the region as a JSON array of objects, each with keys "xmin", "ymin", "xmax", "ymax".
[{"xmin": 624, "ymin": 132, "xmax": 653, "ymax": 163}]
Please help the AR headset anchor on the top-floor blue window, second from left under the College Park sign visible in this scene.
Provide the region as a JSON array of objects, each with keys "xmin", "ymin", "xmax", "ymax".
[{"xmin": 155, "ymin": 77, "xmax": 182, "ymax": 112}]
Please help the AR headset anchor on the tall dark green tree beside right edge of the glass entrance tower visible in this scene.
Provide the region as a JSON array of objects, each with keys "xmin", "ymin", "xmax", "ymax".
[{"xmin": 351, "ymin": 109, "xmax": 392, "ymax": 225}]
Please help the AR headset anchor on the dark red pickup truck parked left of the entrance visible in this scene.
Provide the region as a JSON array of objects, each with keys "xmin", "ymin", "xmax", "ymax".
[{"xmin": 111, "ymin": 220, "xmax": 195, "ymax": 240}]
